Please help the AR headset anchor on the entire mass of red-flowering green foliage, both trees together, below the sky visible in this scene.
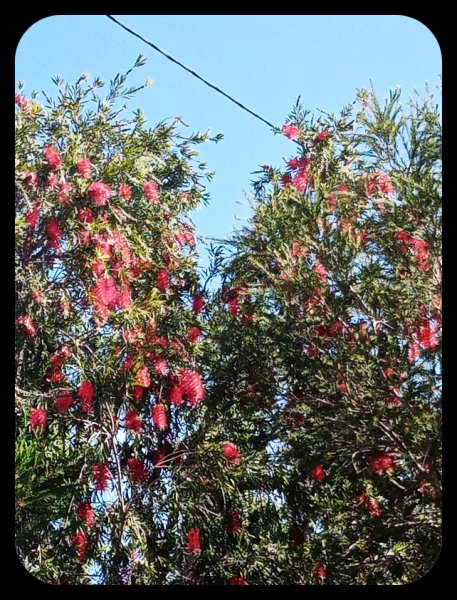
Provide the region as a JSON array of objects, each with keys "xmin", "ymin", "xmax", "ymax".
[{"xmin": 16, "ymin": 63, "xmax": 441, "ymax": 585}]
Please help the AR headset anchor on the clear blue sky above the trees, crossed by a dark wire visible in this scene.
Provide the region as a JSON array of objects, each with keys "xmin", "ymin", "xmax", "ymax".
[{"xmin": 16, "ymin": 15, "xmax": 441, "ymax": 258}]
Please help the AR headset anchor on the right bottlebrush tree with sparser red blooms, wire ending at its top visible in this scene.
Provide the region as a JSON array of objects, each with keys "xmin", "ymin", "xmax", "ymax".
[{"xmin": 202, "ymin": 90, "xmax": 441, "ymax": 584}]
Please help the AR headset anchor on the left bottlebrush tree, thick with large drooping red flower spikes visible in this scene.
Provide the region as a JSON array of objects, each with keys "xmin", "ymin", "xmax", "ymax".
[{"xmin": 16, "ymin": 57, "xmax": 219, "ymax": 583}]
